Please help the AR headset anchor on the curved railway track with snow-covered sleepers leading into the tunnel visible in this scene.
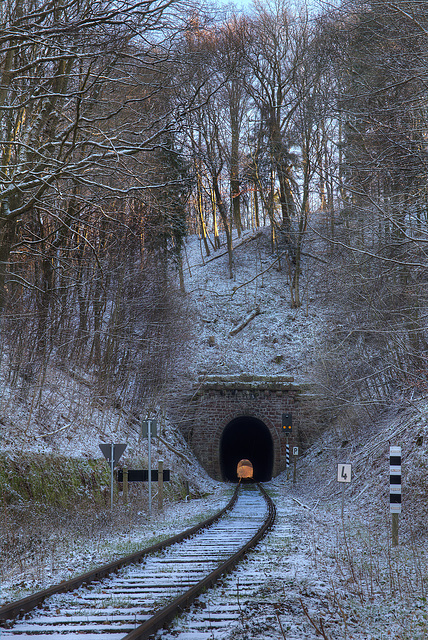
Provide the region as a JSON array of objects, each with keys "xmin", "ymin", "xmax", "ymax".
[{"xmin": 0, "ymin": 485, "xmax": 275, "ymax": 640}]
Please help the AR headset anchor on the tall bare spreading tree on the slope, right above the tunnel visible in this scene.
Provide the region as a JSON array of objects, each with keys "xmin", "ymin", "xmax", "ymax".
[{"xmin": 241, "ymin": 1, "xmax": 326, "ymax": 307}]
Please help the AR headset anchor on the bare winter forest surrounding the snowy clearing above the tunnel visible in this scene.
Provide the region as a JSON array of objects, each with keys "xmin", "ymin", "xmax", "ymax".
[{"xmin": 0, "ymin": 0, "xmax": 428, "ymax": 428}]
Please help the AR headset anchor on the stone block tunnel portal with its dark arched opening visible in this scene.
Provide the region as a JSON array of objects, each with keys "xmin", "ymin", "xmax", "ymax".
[{"xmin": 168, "ymin": 374, "xmax": 311, "ymax": 482}]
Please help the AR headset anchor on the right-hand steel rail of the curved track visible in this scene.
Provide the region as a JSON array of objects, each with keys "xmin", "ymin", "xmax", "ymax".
[{"xmin": 122, "ymin": 485, "xmax": 276, "ymax": 640}]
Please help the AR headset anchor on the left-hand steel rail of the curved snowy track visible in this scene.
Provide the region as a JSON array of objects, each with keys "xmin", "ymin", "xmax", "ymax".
[{"xmin": 0, "ymin": 485, "xmax": 239, "ymax": 625}]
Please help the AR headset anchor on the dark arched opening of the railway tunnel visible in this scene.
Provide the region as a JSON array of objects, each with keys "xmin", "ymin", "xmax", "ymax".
[{"xmin": 220, "ymin": 416, "xmax": 273, "ymax": 482}]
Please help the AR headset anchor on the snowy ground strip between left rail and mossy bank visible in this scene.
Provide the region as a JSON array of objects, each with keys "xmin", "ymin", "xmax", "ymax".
[{"xmin": 0, "ymin": 482, "xmax": 232, "ymax": 604}]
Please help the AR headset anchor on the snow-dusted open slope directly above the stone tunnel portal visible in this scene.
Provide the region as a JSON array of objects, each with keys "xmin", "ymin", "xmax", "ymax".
[{"xmin": 177, "ymin": 228, "xmax": 328, "ymax": 381}]
